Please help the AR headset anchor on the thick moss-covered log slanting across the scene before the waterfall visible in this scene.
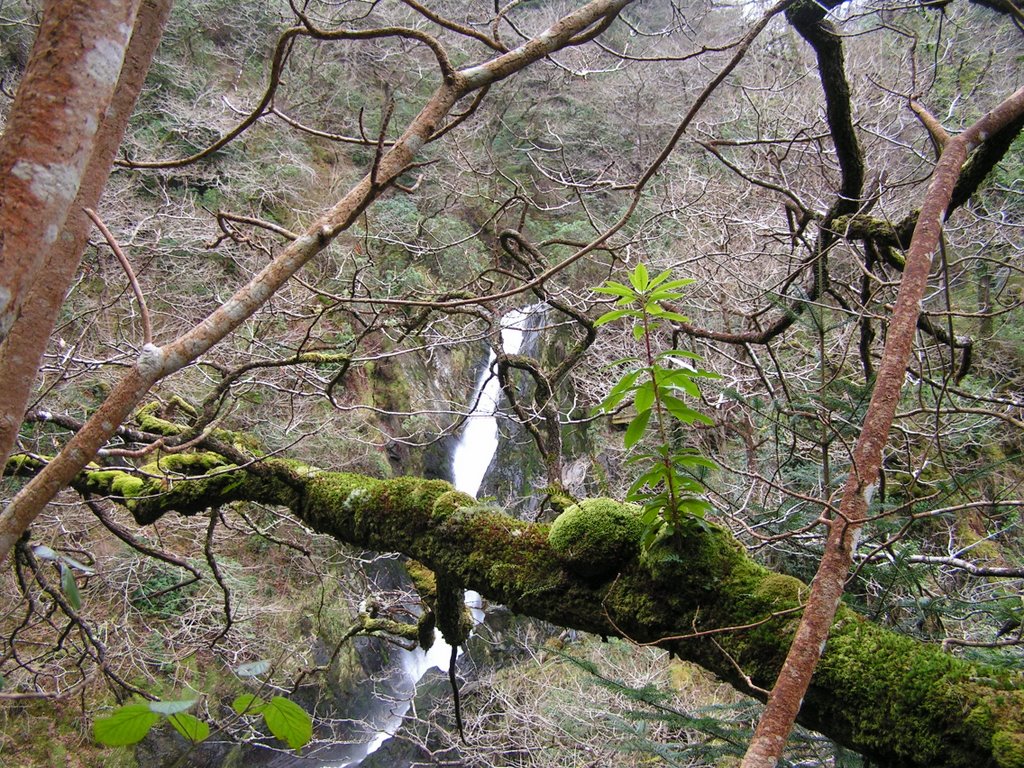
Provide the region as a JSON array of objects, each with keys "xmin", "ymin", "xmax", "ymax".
[{"xmin": 51, "ymin": 453, "xmax": 1024, "ymax": 768}]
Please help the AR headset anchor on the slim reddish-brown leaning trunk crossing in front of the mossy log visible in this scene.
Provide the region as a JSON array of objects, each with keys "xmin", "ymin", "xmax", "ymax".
[{"xmin": 742, "ymin": 83, "xmax": 1024, "ymax": 768}]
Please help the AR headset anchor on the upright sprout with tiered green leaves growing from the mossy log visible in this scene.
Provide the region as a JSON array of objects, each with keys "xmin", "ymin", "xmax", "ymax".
[{"xmin": 594, "ymin": 264, "xmax": 716, "ymax": 548}]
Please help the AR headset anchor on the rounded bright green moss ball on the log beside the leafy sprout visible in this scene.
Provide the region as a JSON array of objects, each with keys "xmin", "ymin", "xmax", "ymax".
[{"xmin": 548, "ymin": 499, "xmax": 643, "ymax": 578}]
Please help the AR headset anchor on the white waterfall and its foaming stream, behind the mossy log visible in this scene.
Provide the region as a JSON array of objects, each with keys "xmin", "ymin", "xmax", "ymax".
[{"xmin": 303, "ymin": 304, "xmax": 545, "ymax": 768}]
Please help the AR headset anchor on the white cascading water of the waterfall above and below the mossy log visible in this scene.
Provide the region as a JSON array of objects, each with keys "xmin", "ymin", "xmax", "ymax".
[{"xmin": 323, "ymin": 304, "xmax": 545, "ymax": 768}]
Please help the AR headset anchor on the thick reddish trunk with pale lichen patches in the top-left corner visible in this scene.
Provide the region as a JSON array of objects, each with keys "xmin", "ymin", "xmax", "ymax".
[{"xmin": 0, "ymin": 0, "xmax": 138, "ymax": 342}]
